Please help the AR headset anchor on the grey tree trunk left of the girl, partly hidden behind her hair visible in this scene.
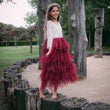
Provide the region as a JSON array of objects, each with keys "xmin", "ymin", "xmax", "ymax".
[{"xmin": 37, "ymin": 0, "xmax": 50, "ymax": 69}]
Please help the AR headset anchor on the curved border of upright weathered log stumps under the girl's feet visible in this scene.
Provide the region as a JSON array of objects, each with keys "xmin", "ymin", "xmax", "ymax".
[{"xmin": 4, "ymin": 57, "xmax": 110, "ymax": 110}]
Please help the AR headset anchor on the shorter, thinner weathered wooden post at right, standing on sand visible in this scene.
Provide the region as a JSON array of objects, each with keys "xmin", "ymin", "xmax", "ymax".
[{"xmin": 94, "ymin": 8, "xmax": 104, "ymax": 58}]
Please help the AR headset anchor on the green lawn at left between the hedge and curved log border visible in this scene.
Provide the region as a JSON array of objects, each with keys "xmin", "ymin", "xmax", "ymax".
[{"xmin": 0, "ymin": 45, "xmax": 39, "ymax": 76}]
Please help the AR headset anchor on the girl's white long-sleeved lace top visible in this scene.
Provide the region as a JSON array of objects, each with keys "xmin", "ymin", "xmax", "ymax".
[{"xmin": 47, "ymin": 21, "xmax": 63, "ymax": 49}]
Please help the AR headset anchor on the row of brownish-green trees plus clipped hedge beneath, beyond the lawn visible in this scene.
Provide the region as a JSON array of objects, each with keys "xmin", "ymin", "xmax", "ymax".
[{"xmin": 0, "ymin": 22, "xmax": 38, "ymax": 46}]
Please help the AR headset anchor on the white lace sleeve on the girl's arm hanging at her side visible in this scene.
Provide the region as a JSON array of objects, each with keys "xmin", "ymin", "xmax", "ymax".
[{"xmin": 47, "ymin": 21, "xmax": 53, "ymax": 49}]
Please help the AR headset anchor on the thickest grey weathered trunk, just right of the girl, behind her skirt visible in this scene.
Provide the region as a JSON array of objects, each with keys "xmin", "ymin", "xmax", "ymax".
[{"xmin": 67, "ymin": 0, "xmax": 88, "ymax": 79}]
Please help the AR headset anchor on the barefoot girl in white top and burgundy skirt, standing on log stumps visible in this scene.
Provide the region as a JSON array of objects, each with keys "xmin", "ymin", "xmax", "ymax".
[{"xmin": 40, "ymin": 3, "xmax": 78, "ymax": 99}]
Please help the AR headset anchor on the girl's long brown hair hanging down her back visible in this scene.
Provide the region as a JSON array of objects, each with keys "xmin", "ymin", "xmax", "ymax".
[{"xmin": 44, "ymin": 3, "xmax": 60, "ymax": 40}]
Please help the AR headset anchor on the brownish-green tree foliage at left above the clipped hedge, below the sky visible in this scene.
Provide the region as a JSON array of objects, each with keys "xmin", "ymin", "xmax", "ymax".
[{"xmin": 0, "ymin": 23, "xmax": 37, "ymax": 42}]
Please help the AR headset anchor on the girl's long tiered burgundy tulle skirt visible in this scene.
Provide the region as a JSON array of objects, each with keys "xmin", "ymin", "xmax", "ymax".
[{"xmin": 39, "ymin": 38, "xmax": 78, "ymax": 91}]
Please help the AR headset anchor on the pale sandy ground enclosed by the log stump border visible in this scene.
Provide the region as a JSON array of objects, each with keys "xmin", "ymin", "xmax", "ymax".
[{"xmin": 22, "ymin": 56, "xmax": 110, "ymax": 104}]
